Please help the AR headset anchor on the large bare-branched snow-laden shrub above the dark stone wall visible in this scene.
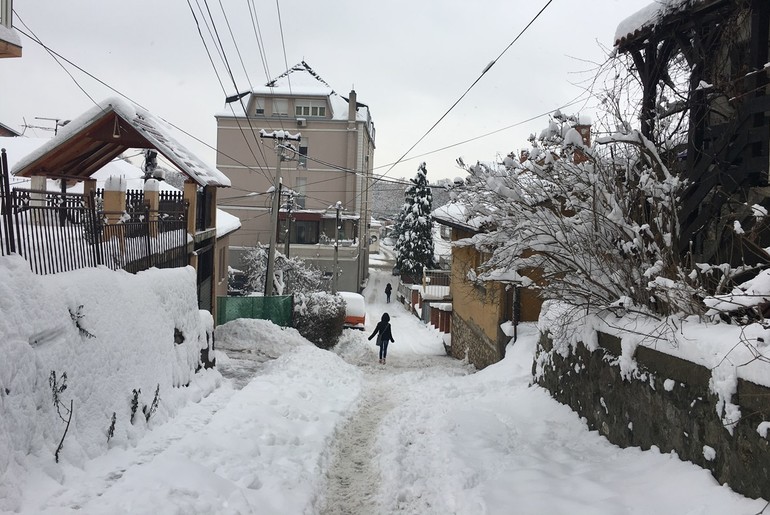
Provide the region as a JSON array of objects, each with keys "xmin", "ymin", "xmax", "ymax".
[{"xmin": 452, "ymin": 112, "xmax": 698, "ymax": 314}]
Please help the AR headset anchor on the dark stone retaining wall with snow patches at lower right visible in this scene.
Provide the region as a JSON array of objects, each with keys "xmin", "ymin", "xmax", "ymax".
[{"xmin": 534, "ymin": 333, "xmax": 770, "ymax": 499}]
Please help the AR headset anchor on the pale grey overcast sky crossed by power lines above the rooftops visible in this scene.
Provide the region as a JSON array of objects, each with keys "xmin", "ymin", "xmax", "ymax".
[{"xmin": 0, "ymin": 0, "xmax": 651, "ymax": 179}]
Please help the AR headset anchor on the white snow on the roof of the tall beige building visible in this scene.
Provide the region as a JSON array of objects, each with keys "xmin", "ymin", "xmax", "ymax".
[{"xmin": 217, "ymin": 61, "xmax": 370, "ymax": 122}]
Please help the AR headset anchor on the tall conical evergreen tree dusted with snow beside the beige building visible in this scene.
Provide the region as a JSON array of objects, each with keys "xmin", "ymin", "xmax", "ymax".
[{"xmin": 396, "ymin": 163, "xmax": 434, "ymax": 276}]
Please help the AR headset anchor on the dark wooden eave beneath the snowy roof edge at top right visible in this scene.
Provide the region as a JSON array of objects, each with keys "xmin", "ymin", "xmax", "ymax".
[{"xmin": 615, "ymin": 0, "xmax": 735, "ymax": 53}]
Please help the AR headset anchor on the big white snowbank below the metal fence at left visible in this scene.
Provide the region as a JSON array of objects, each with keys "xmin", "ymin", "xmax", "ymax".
[{"xmin": 0, "ymin": 256, "xmax": 221, "ymax": 510}]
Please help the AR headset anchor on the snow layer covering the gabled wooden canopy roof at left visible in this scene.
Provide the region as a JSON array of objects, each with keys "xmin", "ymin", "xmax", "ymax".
[{"xmin": 13, "ymin": 98, "xmax": 230, "ymax": 186}]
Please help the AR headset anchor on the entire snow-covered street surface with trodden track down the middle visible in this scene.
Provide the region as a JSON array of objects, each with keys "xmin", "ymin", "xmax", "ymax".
[{"xmin": 4, "ymin": 271, "xmax": 765, "ymax": 515}]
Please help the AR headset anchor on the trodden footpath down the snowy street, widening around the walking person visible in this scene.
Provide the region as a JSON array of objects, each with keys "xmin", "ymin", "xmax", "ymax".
[{"xmin": 316, "ymin": 263, "xmax": 470, "ymax": 515}]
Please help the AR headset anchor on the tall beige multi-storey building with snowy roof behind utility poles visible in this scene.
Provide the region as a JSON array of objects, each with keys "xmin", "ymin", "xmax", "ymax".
[{"xmin": 217, "ymin": 61, "xmax": 375, "ymax": 291}]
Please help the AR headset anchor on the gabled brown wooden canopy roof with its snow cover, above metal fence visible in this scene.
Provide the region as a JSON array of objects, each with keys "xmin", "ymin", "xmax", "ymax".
[{"xmin": 13, "ymin": 99, "xmax": 230, "ymax": 186}]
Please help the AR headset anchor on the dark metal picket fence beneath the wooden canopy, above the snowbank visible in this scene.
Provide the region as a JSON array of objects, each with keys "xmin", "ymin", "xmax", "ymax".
[{"xmin": 0, "ymin": 151, "xmax": 188, "ymax": 274}]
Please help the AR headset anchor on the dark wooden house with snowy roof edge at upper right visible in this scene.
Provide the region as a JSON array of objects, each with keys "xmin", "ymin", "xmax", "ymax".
[{"xmin": 615, "ymin": 0, "xmax": 770, "ymax": 265}]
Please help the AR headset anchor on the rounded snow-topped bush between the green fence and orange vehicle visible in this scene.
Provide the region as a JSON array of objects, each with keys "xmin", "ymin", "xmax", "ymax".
[{"xmin": 294, "ymin": 292, "xmax": 345, "ymax": 349}]
